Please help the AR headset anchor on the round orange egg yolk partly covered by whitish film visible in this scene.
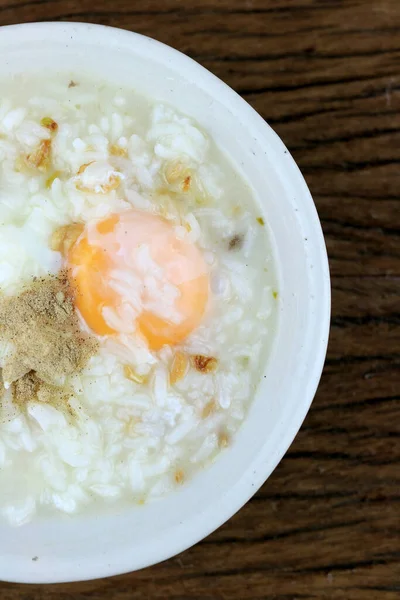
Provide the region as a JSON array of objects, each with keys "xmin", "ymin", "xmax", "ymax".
[{"xmin": 68, "ymin": 210, "xmax": 209, "ymax": 350}]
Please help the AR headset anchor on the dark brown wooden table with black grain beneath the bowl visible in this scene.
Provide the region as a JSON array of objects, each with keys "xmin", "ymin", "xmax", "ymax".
[{"xmin": 0, "ymin": 0, "xmax": 400, "ymax": 600}]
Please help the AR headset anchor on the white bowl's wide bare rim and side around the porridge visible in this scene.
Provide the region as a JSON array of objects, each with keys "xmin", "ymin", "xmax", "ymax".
[{"xmin": 0, "ymin": 23, "xmax": 330, "ymax": 582}]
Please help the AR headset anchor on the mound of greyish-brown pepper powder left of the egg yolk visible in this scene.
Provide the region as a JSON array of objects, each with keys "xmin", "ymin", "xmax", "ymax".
[{"xmin": 0, "ymin": 272, "xmax": 98, "ymax": 403}]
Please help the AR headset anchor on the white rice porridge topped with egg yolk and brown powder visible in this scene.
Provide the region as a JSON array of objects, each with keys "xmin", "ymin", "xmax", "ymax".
[{"xmin": 0, "ymin": 74, "xmax": 279, "ymax": 525}]
